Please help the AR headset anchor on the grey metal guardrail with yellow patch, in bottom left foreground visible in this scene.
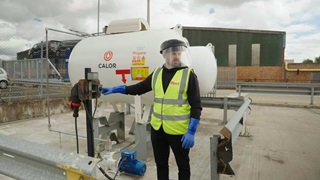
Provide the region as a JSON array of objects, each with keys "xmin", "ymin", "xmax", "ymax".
[{"xmin": 0, "ymin": 134, "xmax": 100, "ymax": 180}]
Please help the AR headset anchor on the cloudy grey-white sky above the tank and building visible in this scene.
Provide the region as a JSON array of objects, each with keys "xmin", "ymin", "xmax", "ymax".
[{"xmin": 0, "ymin": 0, "xmax": 320, "ymax": 62}]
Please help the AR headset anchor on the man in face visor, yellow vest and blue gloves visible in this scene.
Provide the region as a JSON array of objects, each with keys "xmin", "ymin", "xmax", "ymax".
[{"xmin": 102, "ymin": 39, "xmax": 202, "ymax": 180}]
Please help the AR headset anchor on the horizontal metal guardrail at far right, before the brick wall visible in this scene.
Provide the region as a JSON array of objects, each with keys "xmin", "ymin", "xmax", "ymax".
[{"xmin": 237, "ymin": 82, "xmax": 320, "ymax": 105}]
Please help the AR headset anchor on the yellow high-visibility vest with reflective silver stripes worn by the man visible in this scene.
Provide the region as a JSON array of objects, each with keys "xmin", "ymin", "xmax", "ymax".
[{"xmin": 151, "ymin": 68, "xmax": 191, "ymax": 135}]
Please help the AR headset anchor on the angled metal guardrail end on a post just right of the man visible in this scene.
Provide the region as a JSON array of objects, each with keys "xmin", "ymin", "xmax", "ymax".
[{"xmin": 210, "ymin": 99, "xmax": 251, "ymax": 180}]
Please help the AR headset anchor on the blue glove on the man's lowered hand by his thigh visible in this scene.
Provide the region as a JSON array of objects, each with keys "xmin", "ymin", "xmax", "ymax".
[{"xmin": 181, "ymin": 118, "xmax": 200, "ymax": 149}]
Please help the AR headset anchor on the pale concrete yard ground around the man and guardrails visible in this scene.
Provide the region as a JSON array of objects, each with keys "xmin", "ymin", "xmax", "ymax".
[{"xmin": 0, "ymin": 90, "xmax": 320, "ymax": 180}]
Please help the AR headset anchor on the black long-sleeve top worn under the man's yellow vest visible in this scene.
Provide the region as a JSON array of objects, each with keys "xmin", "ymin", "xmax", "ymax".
[{"xmin": 126, "ymin": 66, "xmax": 202, "ymax": 120}]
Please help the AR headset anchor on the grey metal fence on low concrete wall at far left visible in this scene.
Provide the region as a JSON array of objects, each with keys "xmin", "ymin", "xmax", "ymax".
[{"xmin": 0, "ymin": 58, "xmax": 71, "ymax": 103}]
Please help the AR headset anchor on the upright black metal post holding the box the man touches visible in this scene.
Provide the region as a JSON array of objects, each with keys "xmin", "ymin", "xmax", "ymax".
[{"xmin": 83, "ymin": 68, "xmax": 94, "ymax": 157}]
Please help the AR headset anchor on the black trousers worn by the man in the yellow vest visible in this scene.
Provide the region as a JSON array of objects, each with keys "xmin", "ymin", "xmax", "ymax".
[{"xmin": 151, "ymin": 126, "xmax": 190, "ymax": 180}]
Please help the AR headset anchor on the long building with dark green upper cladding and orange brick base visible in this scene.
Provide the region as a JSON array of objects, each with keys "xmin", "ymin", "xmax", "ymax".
[{"xmin": 183, "ymin": 27, "xmax": 320, "ymax": 83}]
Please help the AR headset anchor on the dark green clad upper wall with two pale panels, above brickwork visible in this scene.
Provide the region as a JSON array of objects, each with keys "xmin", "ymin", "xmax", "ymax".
[{"xmin": 183, "ymin": 27, "xmax": 285, "ymax": 66}]
